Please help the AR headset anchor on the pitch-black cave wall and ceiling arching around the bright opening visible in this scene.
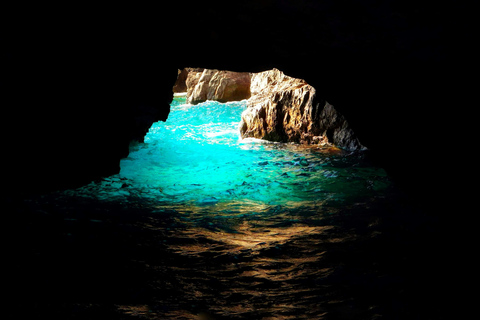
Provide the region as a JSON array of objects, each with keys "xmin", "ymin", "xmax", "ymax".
[{"xmin": 2, "ymin": 0, "xmax": 463, "ymax": 206}]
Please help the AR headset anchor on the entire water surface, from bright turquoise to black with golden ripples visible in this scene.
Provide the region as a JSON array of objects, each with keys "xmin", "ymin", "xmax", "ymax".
[{"xmin": 9, "ymin": 96, "xmax": 444, "ymax": 319}]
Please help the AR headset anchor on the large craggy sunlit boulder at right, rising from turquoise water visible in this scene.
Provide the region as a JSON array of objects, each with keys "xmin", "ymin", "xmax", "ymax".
[{"xmin": 240, "ymin": 69, "xmax": 364, "ymax": 150}]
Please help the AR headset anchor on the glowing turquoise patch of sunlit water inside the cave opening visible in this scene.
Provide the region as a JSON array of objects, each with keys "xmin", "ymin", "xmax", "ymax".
[{"xmin": 66, "ymin": 97, "xmax": 390, "ymax": 210}]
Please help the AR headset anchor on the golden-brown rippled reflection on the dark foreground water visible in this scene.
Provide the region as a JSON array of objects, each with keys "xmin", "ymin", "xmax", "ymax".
[{"xmin": 120, "ymin": 202, "xmax": 360, "ymax": 319}]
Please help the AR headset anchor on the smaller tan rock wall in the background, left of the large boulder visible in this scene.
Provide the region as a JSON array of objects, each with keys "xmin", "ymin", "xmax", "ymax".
[{"xmin": 176, "ymin": 68, "xmax": 251, "ymax": 104}]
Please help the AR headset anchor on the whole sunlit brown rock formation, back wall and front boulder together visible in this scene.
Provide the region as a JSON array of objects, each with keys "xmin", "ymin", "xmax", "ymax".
[{"xmin": 173, "ymin": 68, "xmax": 365, "ymax": 150}]
